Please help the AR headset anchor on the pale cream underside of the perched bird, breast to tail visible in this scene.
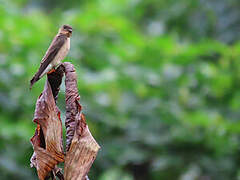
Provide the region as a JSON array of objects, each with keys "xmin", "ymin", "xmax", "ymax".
[{"xmin": 40, "ymin": 38, "xmax": 70, "ymax": 78}]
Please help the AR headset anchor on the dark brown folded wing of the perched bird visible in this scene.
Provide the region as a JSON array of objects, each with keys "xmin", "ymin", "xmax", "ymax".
[{"xmin": 30, "ymin": 35, "xmax": 67, "ymax": 87}]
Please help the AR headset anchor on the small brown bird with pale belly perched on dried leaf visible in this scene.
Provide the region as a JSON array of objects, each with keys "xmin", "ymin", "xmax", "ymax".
[{"xmin": 30, "ymin": 25, "xmax": 73, "ymax": 89}]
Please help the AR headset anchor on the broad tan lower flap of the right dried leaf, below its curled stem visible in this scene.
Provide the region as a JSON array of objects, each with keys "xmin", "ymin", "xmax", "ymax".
[{"xmin": 64, "ymin": 112, "xmax": 100, "ymax": 180}]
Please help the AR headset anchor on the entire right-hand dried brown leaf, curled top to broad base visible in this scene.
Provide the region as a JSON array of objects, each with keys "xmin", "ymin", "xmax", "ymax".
[{"xmin": 64, "ymin": 63, "xmax": 100, "ymax": 180}]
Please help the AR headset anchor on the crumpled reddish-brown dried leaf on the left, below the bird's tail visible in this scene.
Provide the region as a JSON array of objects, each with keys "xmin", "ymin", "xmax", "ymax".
[{"xmin": 31, "ymin": 81, "xmax": 64, "ymax": 180}]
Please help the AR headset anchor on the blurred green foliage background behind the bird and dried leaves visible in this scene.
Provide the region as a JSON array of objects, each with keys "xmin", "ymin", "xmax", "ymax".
[{"xmin": 0, "ymin": 0, "xmax": 240, "ymax": 180}]
